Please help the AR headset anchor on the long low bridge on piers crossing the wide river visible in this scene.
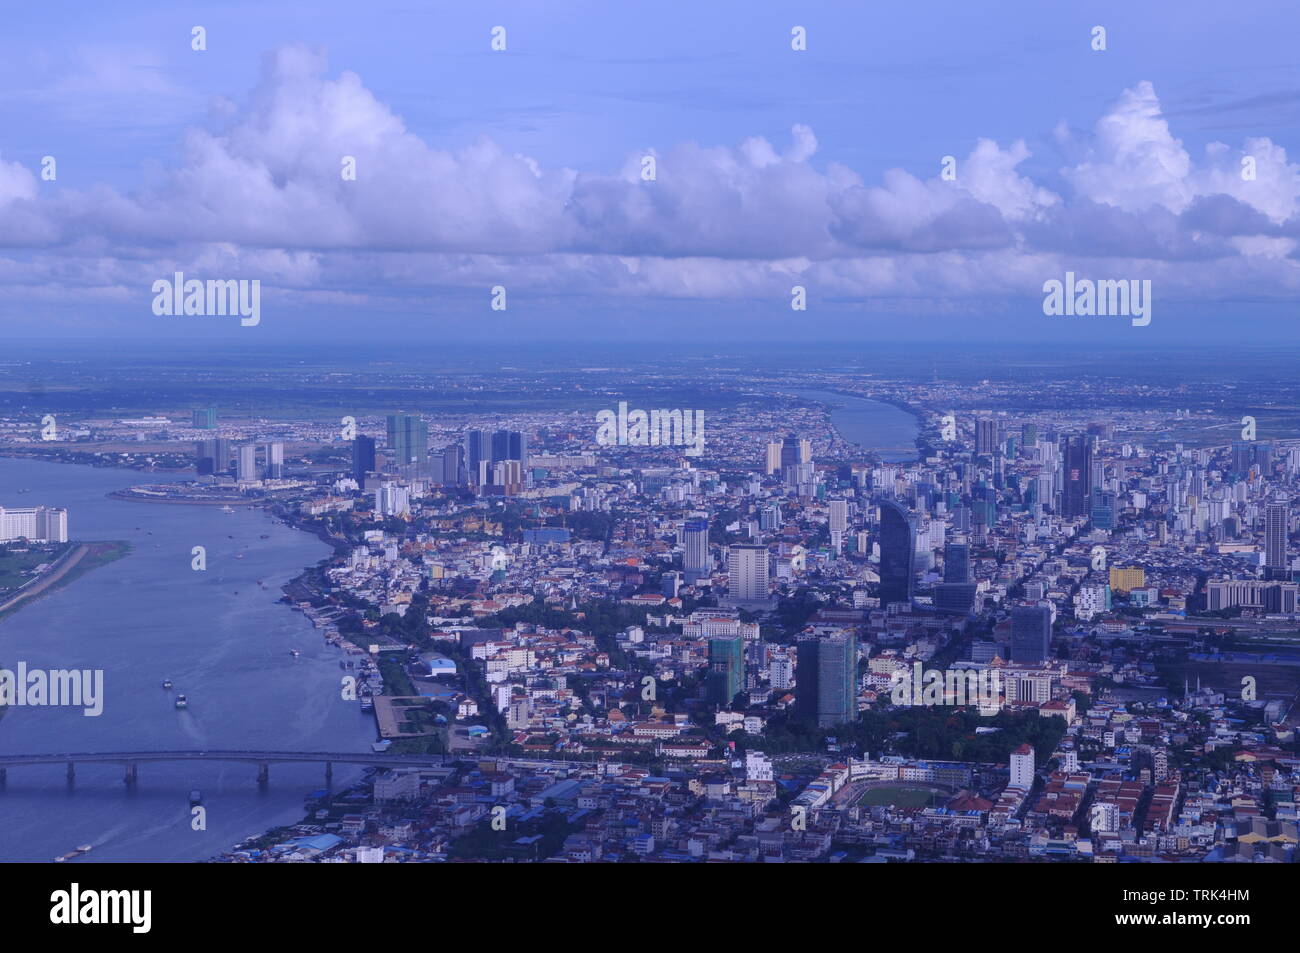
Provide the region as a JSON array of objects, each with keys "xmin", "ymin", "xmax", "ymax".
[{"xmin": 0, "ymin": 750, "xmax": 447, "ymax": 784}]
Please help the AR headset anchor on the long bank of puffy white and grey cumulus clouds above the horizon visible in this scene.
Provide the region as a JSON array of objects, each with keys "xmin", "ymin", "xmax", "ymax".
[{"xmin": 0, "ymin": 47, "xmax": 1300, "ymax": 314}]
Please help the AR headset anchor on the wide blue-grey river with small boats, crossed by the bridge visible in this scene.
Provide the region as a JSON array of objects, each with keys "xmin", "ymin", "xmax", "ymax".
[{"xmin": 0, "ymin": 458, "xmax": 374, "ymax": 865}]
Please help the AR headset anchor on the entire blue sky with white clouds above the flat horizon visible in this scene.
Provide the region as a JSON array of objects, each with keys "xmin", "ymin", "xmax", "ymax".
[{"xmin": 0, "ymin": 0, "xmax": 1300, "ymax": 347}]
